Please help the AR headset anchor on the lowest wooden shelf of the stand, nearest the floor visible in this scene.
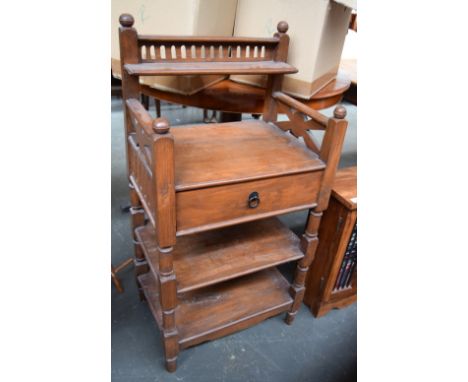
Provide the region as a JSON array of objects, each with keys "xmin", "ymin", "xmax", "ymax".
[{"xmin": 138, "ymin": 268, "xmax": 293, "ymax": 349}]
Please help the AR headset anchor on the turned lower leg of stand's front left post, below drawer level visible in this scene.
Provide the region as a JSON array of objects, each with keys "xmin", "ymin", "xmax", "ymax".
[{"xmin": 159, "ymin": 247, "xmax": 179, "ymax": 372}]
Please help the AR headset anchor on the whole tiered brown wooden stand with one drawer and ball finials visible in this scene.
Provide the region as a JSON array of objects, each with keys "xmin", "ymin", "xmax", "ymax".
[{"xmin": 120, "ymin": 15, "xmax": 347, "ymax": 371}]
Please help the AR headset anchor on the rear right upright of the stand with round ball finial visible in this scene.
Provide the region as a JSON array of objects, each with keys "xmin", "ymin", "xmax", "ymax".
[{"xmin": 263, "ymin": 21, "xmax": 289, "ymax": 122}]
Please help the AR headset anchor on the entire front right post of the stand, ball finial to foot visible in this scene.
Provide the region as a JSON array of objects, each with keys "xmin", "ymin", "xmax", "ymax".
[{"xmin": 286, "ymin": 106, "xmax": 348, "ymax": 325}]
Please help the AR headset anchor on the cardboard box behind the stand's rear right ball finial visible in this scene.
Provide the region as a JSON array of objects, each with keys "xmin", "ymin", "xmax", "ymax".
[{"xmin": 231, "ymin": 0, "xmax": 351, "ymax": 99}]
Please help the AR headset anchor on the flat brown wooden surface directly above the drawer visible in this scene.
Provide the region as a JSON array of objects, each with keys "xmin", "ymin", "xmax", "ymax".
[{"xmin": 171, "ymin": 120, "xmax": 325, "ymax": 191}]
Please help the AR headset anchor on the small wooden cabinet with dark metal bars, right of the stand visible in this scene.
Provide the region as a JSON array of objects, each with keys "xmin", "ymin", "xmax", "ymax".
[{"xmin": 304, "ymin": 167, "xmax": 357, "ymax": 317}]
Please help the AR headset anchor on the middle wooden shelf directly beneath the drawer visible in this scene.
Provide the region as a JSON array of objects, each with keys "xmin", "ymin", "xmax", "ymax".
[{"xmin": 136, "ymin": 218, "xmax": 304, "ymax": 293}]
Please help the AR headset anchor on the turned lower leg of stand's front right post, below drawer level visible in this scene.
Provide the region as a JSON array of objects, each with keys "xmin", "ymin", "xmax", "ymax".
[{"xmin": 286, "ymin": 210, "xmax": 322, "ymax": 325}]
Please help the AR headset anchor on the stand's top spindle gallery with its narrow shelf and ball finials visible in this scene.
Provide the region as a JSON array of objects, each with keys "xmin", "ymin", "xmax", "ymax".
[{"xmin": 121, "ymin": 15, "xmax": 297, "ymax": 76}]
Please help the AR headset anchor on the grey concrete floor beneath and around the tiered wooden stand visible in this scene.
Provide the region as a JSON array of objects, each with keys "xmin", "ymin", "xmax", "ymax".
[{"xmin": 111, "ymin": 98, "xmax": 357, "ymax": 382}]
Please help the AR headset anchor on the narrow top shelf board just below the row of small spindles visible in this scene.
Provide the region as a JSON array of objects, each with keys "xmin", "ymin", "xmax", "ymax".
[{"xmin": 125, "ymin": 60, "xmax": 298, "ymax": 76}]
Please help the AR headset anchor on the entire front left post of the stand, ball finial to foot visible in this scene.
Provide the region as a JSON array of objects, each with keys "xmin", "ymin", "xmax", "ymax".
[{"xmin": 153, "ymin": 118, "xmax": 179, "ymax": 372}]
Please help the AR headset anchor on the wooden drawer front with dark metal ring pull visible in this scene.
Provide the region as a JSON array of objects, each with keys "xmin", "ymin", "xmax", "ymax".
[{"xmin": 176, "ymin": 171, "xmax": 323, "ymax": 236}]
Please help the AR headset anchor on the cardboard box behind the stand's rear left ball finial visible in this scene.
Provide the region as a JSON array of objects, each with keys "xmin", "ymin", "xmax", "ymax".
[{"xmin": 111, "ymin": 0, "xmax": 237, "ymax": 95}]
